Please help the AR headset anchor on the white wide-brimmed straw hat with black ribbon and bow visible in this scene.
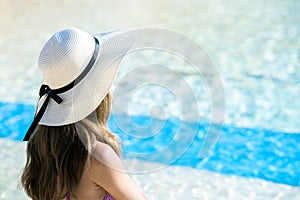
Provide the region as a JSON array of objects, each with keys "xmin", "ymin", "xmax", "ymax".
[{"xmin": 24, "ymin": 28, "xmax": 136, "ymax": 141}]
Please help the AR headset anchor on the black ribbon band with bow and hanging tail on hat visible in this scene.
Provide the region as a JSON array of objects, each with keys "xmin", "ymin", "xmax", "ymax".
[{"xmin": 23, "ymin": 37, "xmax": 99, "ymax": 141}]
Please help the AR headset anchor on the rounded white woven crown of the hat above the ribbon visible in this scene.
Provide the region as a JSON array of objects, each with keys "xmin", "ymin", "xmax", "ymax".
[{"xmin": 38, "ymin": 28, "xmax": 95, "ymax": 89}]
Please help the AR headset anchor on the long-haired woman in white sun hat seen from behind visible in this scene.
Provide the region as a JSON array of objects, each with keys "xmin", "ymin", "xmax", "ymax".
[{"xmin": 21, "ymin": 28, "xmax": 145, "ymax": 200}]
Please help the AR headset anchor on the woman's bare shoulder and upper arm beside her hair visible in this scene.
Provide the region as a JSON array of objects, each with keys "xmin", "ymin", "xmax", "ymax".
[{"xmin": 89, "ymin": 142, "xmax": 146, "ymax": 200}]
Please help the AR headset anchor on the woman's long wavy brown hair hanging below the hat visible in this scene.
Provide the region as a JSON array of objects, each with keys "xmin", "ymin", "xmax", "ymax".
[{"xmin": 21, "ymin": 93, "xmax": 120, "ymax": 200}]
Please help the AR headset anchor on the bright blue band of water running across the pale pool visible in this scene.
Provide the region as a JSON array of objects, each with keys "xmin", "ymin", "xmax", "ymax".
[{"xmin": 0, "ymin": 102, "xmax": 300, "ymax": 186}]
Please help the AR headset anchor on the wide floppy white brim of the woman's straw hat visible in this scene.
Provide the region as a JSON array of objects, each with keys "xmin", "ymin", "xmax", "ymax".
[{"xmin": 37, "ymin": 31, "xmax": 136, "ymax": 126}]
